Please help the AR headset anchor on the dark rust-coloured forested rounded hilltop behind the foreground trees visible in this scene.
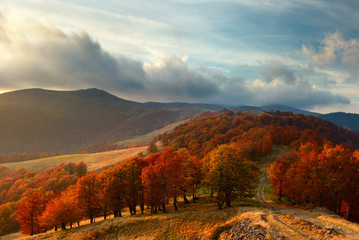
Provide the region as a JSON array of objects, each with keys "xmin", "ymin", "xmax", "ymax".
[{"xmin": 163, "ymin": 110, "xmax": 359, "ymax": 159}]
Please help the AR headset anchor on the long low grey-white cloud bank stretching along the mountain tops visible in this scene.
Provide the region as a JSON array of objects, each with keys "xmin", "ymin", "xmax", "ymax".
[{"xmin": 0, "ymin": 11, "xmax": 349, "ymax": 108}]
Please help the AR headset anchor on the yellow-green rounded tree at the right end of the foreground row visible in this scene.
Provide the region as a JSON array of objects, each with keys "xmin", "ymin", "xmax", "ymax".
[{"xmin": 204, "ymin": 145, "xmax": 259, "ymax": 208}]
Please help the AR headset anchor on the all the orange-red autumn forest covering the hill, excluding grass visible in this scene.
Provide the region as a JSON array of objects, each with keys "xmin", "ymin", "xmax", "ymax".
[{"xmin": 0, "ymin": 111, "xmax": 359, "ymax": 235}]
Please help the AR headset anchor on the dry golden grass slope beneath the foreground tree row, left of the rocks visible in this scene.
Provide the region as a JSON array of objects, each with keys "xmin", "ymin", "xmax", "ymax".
[{"xmin": 17, "ymin": 200, "xmax": 262, "ymax": 240}]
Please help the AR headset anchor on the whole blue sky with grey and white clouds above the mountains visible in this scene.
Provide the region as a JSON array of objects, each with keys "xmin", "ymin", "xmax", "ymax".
[{"xmin": 0, "ymin": 0, "xmax": 359, "ymax": 113}]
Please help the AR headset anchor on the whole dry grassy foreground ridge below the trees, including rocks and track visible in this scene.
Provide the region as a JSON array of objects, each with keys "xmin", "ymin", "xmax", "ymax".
[{"xmin": 15, "ymin": 200, "xmax": 359, "ymax": 240}]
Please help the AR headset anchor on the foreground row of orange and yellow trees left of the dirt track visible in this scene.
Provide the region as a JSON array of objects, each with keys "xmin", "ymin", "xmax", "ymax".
[{"xmin": 17, "ymin": 145, "xmax": 259, "ymax": 235}]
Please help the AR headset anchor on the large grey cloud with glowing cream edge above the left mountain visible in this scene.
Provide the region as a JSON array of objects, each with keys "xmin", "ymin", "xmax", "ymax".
[{"xmin": 0, "ymin": 13, "xmax": 145, "ymax": 91}]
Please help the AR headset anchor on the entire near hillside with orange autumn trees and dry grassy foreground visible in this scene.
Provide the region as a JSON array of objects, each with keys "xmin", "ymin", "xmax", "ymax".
[{"xmin": 0, "ymin": 109, "xmax": 359, "ymax": 239}]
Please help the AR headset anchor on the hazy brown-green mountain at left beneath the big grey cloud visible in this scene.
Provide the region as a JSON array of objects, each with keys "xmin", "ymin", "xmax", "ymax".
[{"xmin": 0, "ymin": 89, "xmax": 203, "ymax": 154}]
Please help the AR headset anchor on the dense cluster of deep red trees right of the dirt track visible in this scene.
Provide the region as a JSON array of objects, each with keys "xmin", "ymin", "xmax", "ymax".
[{"xmin": 268, "ymin": 142, "xmax": 359, "ymax": 221}]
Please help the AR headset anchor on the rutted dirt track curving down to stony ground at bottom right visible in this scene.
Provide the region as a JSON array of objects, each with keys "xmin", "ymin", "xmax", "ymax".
[{"xmin": 256, "ymin": 172, "xmax": 359, "ymax": 239}]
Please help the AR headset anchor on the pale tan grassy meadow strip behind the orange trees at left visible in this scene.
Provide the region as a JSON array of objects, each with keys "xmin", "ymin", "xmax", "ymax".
[{"xmin": 0, "ymin": 146, "xmax": 147, "ymax": 172}]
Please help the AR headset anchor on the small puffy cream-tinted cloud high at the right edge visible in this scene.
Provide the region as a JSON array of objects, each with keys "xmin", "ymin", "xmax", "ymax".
[{"xmin": 302, "ymin": 32, "xmax": 359, "ymax": 83}]
